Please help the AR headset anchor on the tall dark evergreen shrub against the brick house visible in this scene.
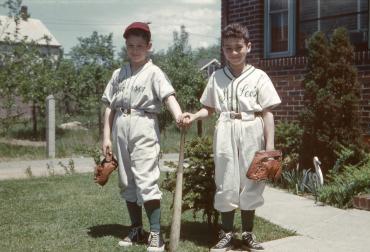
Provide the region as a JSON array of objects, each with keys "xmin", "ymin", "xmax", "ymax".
[{"xmin": 300, "ymin": 28, "xmax": 362, "ymax": 171}]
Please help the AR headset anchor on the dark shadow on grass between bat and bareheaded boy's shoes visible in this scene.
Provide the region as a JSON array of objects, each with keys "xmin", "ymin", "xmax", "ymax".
[{"xmin": 162, "ymin": 220, "xmax": 220, "ymax": 247}]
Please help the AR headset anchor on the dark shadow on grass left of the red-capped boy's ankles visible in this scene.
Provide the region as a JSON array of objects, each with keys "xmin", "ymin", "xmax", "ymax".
[{"xmin": 87, "ymin": 224, "xmax": 131, "ymax": 239}]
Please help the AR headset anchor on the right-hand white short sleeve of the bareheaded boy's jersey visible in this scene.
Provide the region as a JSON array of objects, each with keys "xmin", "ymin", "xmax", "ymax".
[{"xmin": 257, "ymin": 73, "xmax": 281, "ymax": 108}]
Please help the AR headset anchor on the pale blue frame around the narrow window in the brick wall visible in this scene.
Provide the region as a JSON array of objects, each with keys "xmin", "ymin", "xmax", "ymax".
[{"xmin": 264, "ymin": 0, "xmax": 296, "ymax": 58}]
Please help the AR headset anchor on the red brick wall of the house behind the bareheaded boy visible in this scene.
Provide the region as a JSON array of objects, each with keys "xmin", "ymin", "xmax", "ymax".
[{"xmin": 221, "ymin": 0, "xmax": 370, "ymax": 135}]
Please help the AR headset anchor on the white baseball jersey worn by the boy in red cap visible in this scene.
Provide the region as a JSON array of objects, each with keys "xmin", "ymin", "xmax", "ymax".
[{"xmin": 102, "ymin": 62, "xmax": 175, "ymax": 114}]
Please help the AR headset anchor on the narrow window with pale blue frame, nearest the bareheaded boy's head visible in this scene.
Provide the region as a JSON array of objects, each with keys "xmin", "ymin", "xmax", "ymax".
[{"xmin": 265, "ymin": 0, "xmax": 295, "ymax": 57}]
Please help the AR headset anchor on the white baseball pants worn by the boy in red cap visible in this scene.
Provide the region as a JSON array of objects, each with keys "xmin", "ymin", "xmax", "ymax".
[{"xmin": 112, "ymin": 109, "xmax": 162, "ymax": 206}]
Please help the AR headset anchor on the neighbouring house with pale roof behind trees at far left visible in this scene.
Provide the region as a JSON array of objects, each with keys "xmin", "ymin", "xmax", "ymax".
[{"xmin": 0, "ymin": 6, "xmax": 61, "ymax": 118}]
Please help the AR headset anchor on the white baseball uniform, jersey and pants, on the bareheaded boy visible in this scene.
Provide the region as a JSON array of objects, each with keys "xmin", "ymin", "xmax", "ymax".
[{"xmin": 200, "ymin": 67, "xmax": 280, "ymax": 212}]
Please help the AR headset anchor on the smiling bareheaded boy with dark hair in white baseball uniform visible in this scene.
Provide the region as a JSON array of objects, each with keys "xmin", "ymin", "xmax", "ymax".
[{"xmin": 180, "ymin": 23, "xmax": 281, "ymax": 252}]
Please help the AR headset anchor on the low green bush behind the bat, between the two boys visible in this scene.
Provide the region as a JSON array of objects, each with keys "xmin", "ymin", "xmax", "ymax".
[{"xmin": 162, "ymin": 137, "xmax": 219, "ymax": 228}]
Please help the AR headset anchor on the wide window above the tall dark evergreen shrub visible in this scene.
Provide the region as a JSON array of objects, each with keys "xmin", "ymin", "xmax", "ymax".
[{"xmin": 298, "ymin": 0, "xmax": 369, "ymax": 54}]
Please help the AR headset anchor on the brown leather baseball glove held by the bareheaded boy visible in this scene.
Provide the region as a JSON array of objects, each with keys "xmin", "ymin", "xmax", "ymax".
[{"xmin": 247, "ymin": 150, "xmax": 282, "ymax": 182}]
